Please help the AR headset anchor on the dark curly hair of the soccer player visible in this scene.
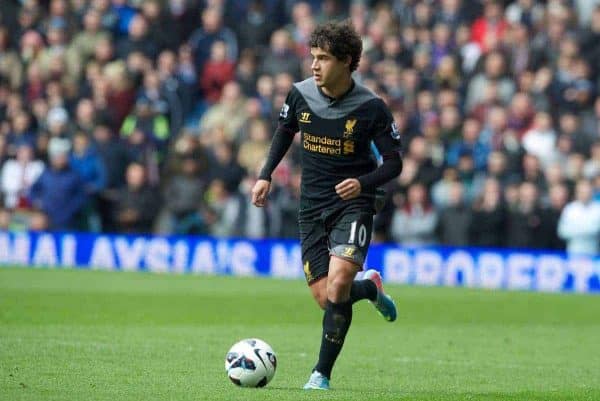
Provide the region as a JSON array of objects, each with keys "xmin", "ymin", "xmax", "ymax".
[{"xmin": 308, "ymin": 20, "xmax": 362, "ymax": 71}]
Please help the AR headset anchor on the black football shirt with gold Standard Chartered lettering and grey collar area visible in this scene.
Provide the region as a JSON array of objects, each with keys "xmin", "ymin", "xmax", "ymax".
[{"xmin": 279, "ymin": 78, "xmax": 402, "ymax": 214}]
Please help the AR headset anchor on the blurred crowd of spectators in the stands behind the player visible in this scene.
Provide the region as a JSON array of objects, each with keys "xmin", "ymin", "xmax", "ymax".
[{"xmin": 0, "ymin": 0, "xmax": 600, "ymax": 253}]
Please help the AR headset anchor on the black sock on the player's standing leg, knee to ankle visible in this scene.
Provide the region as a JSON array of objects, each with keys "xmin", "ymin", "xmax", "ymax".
[{"xmin": 315, "ymin": 300, "xmax": 352, "ymax": 378}]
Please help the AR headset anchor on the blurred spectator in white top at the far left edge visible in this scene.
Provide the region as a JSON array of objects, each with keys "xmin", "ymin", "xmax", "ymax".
[{"xmin": 0, "ymin": 142, "xmax": 44, "ymax": 209}]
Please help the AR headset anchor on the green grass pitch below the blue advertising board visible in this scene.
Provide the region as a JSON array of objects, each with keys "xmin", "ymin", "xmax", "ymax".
[{"xmin": 0, "ymin": 268, "xmax": 600, "ymax": 401}]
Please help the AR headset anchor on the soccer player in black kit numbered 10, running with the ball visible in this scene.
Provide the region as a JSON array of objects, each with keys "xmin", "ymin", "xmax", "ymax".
[{"xmin": 252, "ymin": 22, "xmax": 402, "ymax": 390}]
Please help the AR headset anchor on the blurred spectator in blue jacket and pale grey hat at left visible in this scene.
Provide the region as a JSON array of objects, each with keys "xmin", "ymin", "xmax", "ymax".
[{"xmin": 31, "ymin": 137, "xmax": 86, "ymax": 231}]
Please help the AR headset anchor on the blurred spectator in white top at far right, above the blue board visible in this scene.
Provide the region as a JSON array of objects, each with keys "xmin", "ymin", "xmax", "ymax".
[{"xmin": 558, "ymin": 180, "xmax": 600, "ymax": 255}]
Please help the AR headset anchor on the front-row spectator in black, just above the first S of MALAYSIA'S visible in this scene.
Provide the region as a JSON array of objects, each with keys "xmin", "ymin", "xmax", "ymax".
[{"xmin": 113, "ymin": 163, "xmax": 160, "ymax": 233}]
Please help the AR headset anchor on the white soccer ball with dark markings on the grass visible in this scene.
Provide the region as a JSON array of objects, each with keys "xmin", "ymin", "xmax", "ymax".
[{"xmin": 225, "ymin": 338, "xmax": 277, "ymax": 387}]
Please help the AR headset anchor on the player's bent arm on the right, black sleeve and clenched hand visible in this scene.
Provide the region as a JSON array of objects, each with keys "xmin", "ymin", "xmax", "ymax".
[{"xmin": 335, "ymin": 101, "xmax": 402, "ymax": 200}]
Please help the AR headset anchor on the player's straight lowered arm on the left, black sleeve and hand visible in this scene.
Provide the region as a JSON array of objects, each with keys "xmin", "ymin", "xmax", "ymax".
[{"xmin": 252, "ymin": 88, "xmax": 299, "ymax": 207}]
